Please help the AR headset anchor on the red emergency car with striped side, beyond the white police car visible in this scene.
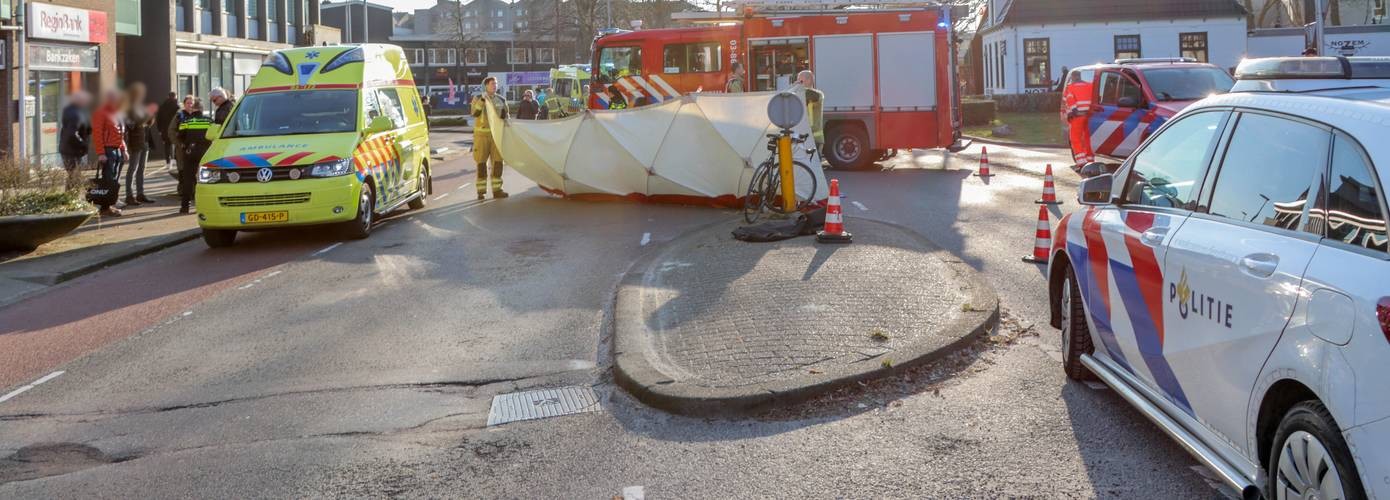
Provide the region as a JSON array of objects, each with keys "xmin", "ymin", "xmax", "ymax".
[{"xmin": 1061, "ymin": 57, "xmax": 1236, "ymax": 158}]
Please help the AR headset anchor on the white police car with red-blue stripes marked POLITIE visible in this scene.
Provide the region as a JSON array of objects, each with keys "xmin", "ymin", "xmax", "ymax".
[{"xmin": 1048, "ymin": 57, "xmax": 1390, "ymax": 499}]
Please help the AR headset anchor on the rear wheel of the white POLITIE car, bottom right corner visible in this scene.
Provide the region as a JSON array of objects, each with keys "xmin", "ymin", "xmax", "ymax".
[{"xmin": 1265, "ymin": 400, "xmax": 1366, "ymax": 500}]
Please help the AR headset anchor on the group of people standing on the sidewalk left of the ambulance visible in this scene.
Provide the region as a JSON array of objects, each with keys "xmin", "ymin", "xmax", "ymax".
[{"xmin": 58, "ymin": 82, "xmax": 235, "ymax": 217}]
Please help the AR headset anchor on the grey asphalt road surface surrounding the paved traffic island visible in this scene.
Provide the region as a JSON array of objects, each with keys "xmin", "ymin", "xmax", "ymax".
[{"xmin": 0, "ymin": 138, "xmax": 1219, "ymax": 499}]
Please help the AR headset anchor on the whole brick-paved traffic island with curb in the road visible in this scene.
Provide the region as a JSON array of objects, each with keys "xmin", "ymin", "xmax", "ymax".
[{"xmin": 613, "ymin": 218, "xmax": 999, "ymax": 415}]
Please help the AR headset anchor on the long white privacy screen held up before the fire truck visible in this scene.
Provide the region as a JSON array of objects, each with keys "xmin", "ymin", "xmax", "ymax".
[{"xmin": 488, "ymin": 88, "xmax": 828, "ymax": 206}]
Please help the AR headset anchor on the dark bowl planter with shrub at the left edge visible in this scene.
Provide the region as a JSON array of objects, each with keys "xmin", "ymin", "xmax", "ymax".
[{"xmin": 0, "ymin": 158, "xmax": 95, "ymax": 251}]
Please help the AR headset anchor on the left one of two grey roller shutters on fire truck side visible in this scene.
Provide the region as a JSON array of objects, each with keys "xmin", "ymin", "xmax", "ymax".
[{"xmin": 812, "ymin": 35, "xmax": 872, "ymax": 111}]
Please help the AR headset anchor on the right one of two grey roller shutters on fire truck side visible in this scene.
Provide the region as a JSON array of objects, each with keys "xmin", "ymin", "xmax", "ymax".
[{"xmin": 872, "ymin": 32, "xmax": 937, "ymax": 111}]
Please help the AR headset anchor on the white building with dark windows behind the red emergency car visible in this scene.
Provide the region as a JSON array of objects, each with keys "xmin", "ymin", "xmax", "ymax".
[{"xmin": 977, "ymin": 0, "xmax": 1247, "ymax": 94}]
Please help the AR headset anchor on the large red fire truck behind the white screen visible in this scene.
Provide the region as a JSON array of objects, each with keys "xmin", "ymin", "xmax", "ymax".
[{"xmin": 589, "ymin": 0, "xmax": 963, "ymax": 168}]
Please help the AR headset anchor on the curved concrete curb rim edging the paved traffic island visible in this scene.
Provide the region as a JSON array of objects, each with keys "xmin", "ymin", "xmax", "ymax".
[{"xmin": 612, "ymin": 217, "xmax": 999, "ymax": 417}]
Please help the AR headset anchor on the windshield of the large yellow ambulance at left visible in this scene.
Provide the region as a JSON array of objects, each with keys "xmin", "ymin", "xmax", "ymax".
[{"xmin": 222, "ymin": 90, "xmax": 357, "ymax": 138}]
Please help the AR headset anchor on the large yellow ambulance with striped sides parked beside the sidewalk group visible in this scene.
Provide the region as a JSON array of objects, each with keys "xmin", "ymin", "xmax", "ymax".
[{"xmin": 195, "ymin": 44, "xmax": 431, "ymax": 247}]
